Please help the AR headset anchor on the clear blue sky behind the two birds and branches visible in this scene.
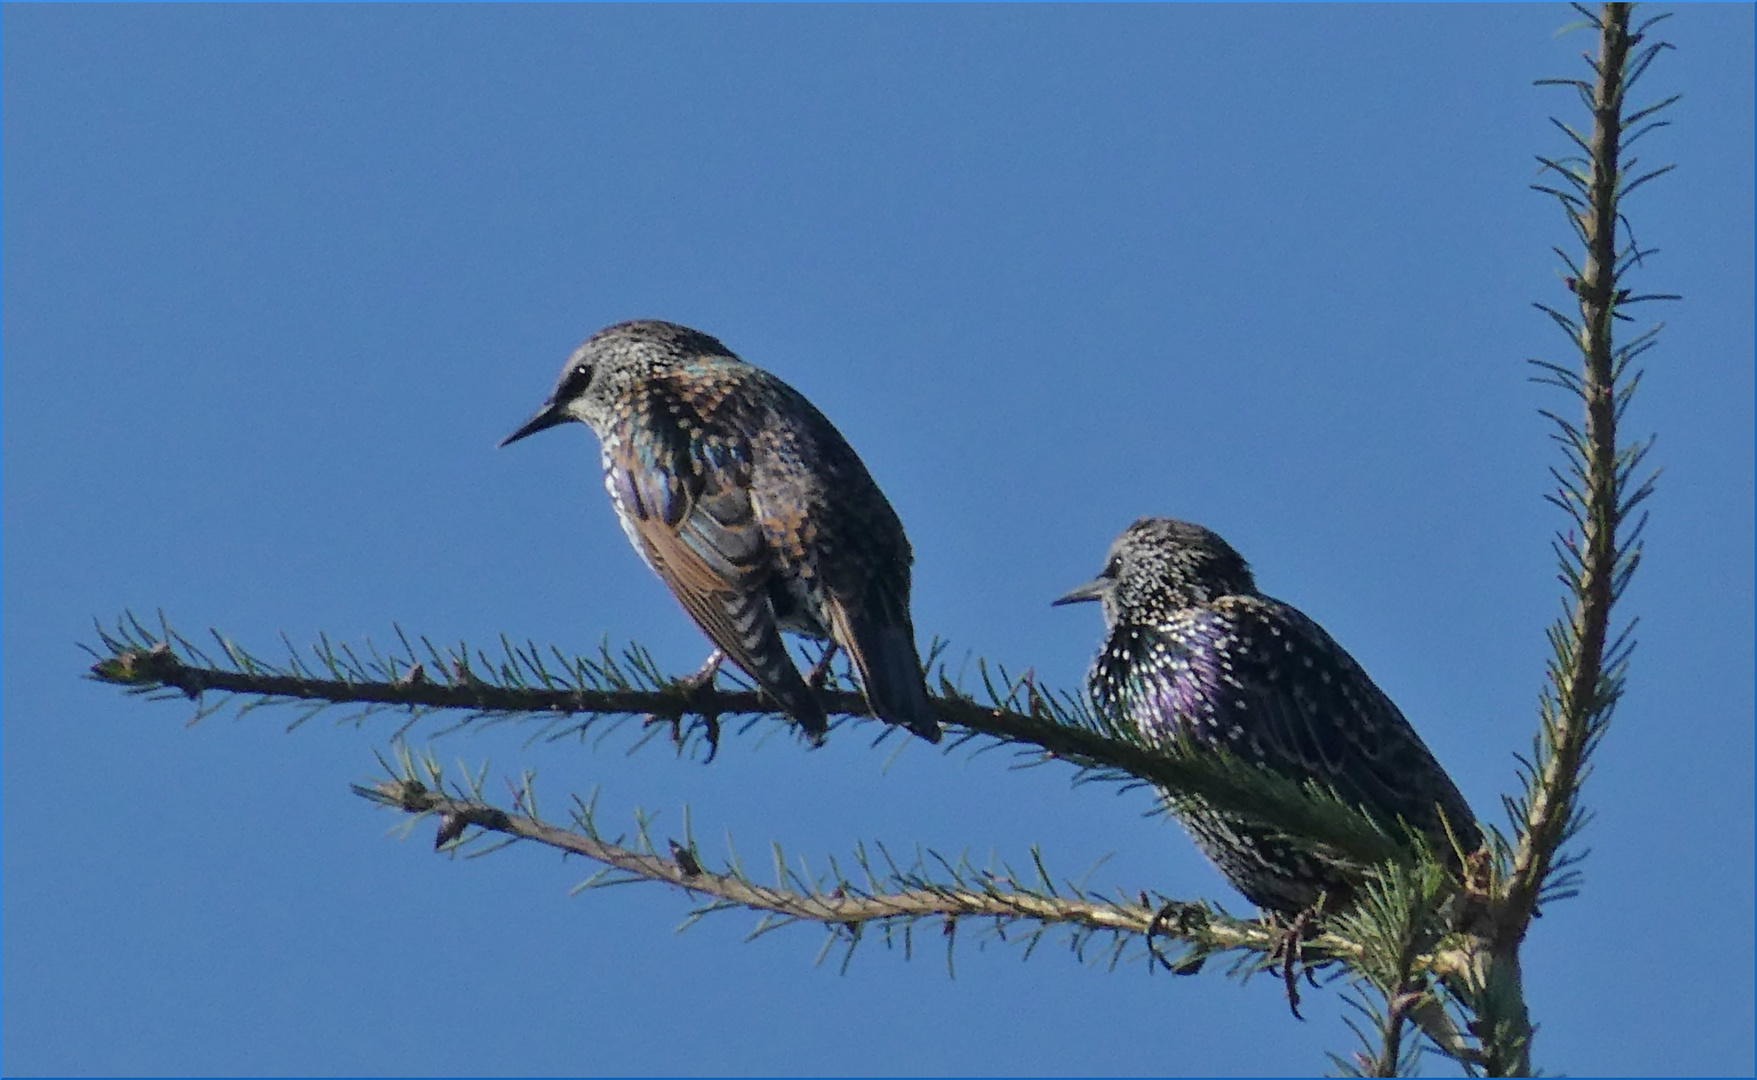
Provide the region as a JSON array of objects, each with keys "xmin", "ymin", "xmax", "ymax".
[{"xmin": 0, "ymin": 5, "xmax": 1753, "ymax": 1075}]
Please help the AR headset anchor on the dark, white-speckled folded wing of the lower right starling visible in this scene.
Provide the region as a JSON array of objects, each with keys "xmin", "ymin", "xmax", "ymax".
[{"xmin": 1132, "ymin": 597, "xmax": 1478, "ymax": 846}]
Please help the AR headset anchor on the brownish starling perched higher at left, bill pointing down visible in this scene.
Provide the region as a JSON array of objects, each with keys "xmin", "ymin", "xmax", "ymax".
[{"xmin": 501, "ymin": 321, "xmax": 940, "ymax": 743}]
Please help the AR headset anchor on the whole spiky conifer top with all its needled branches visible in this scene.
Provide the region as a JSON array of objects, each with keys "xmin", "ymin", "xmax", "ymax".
[{"xmin": 72, "ymin": 4, "xmax": 1678, "ymax": 1076}]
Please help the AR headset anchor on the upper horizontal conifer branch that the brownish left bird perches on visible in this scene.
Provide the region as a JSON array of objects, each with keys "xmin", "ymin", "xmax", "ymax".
[{"xmin": 88, "ymin": 615, "xmax": 1409, "ymax": 868}]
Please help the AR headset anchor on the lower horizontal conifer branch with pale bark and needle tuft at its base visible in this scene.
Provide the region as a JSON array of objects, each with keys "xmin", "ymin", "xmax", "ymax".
[{"xmin": 353, "ymin": 746, "xmax": 1479, "ymax": 1075}]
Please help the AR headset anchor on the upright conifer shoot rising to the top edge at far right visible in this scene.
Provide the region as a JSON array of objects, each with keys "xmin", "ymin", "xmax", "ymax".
[{"xmin": 1497, "ymin": 4, "xmax": 1676, "ymax": 945}]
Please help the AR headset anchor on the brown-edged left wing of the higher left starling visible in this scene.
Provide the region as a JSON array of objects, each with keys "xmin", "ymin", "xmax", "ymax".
[{"xmin": 606, "ymin": 393, "xmax": 822, "ymax": 731}]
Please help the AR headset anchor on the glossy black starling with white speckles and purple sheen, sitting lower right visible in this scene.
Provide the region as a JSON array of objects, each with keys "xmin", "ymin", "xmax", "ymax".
[{"xmin": 1056, "ymin": 518, "xmax": 1481, "ymax": 915}]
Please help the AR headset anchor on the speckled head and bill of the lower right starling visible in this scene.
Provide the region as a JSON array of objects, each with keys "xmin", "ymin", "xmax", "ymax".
[{"xmin": 1054, "ymin": 518, "xmax": 1256, "ymax": 627}]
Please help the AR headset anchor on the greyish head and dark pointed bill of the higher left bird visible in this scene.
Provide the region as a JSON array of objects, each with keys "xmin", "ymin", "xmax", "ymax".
[{"xmin": 501, "ymin": 320, "xmax": 736, "ymax": 446}]
